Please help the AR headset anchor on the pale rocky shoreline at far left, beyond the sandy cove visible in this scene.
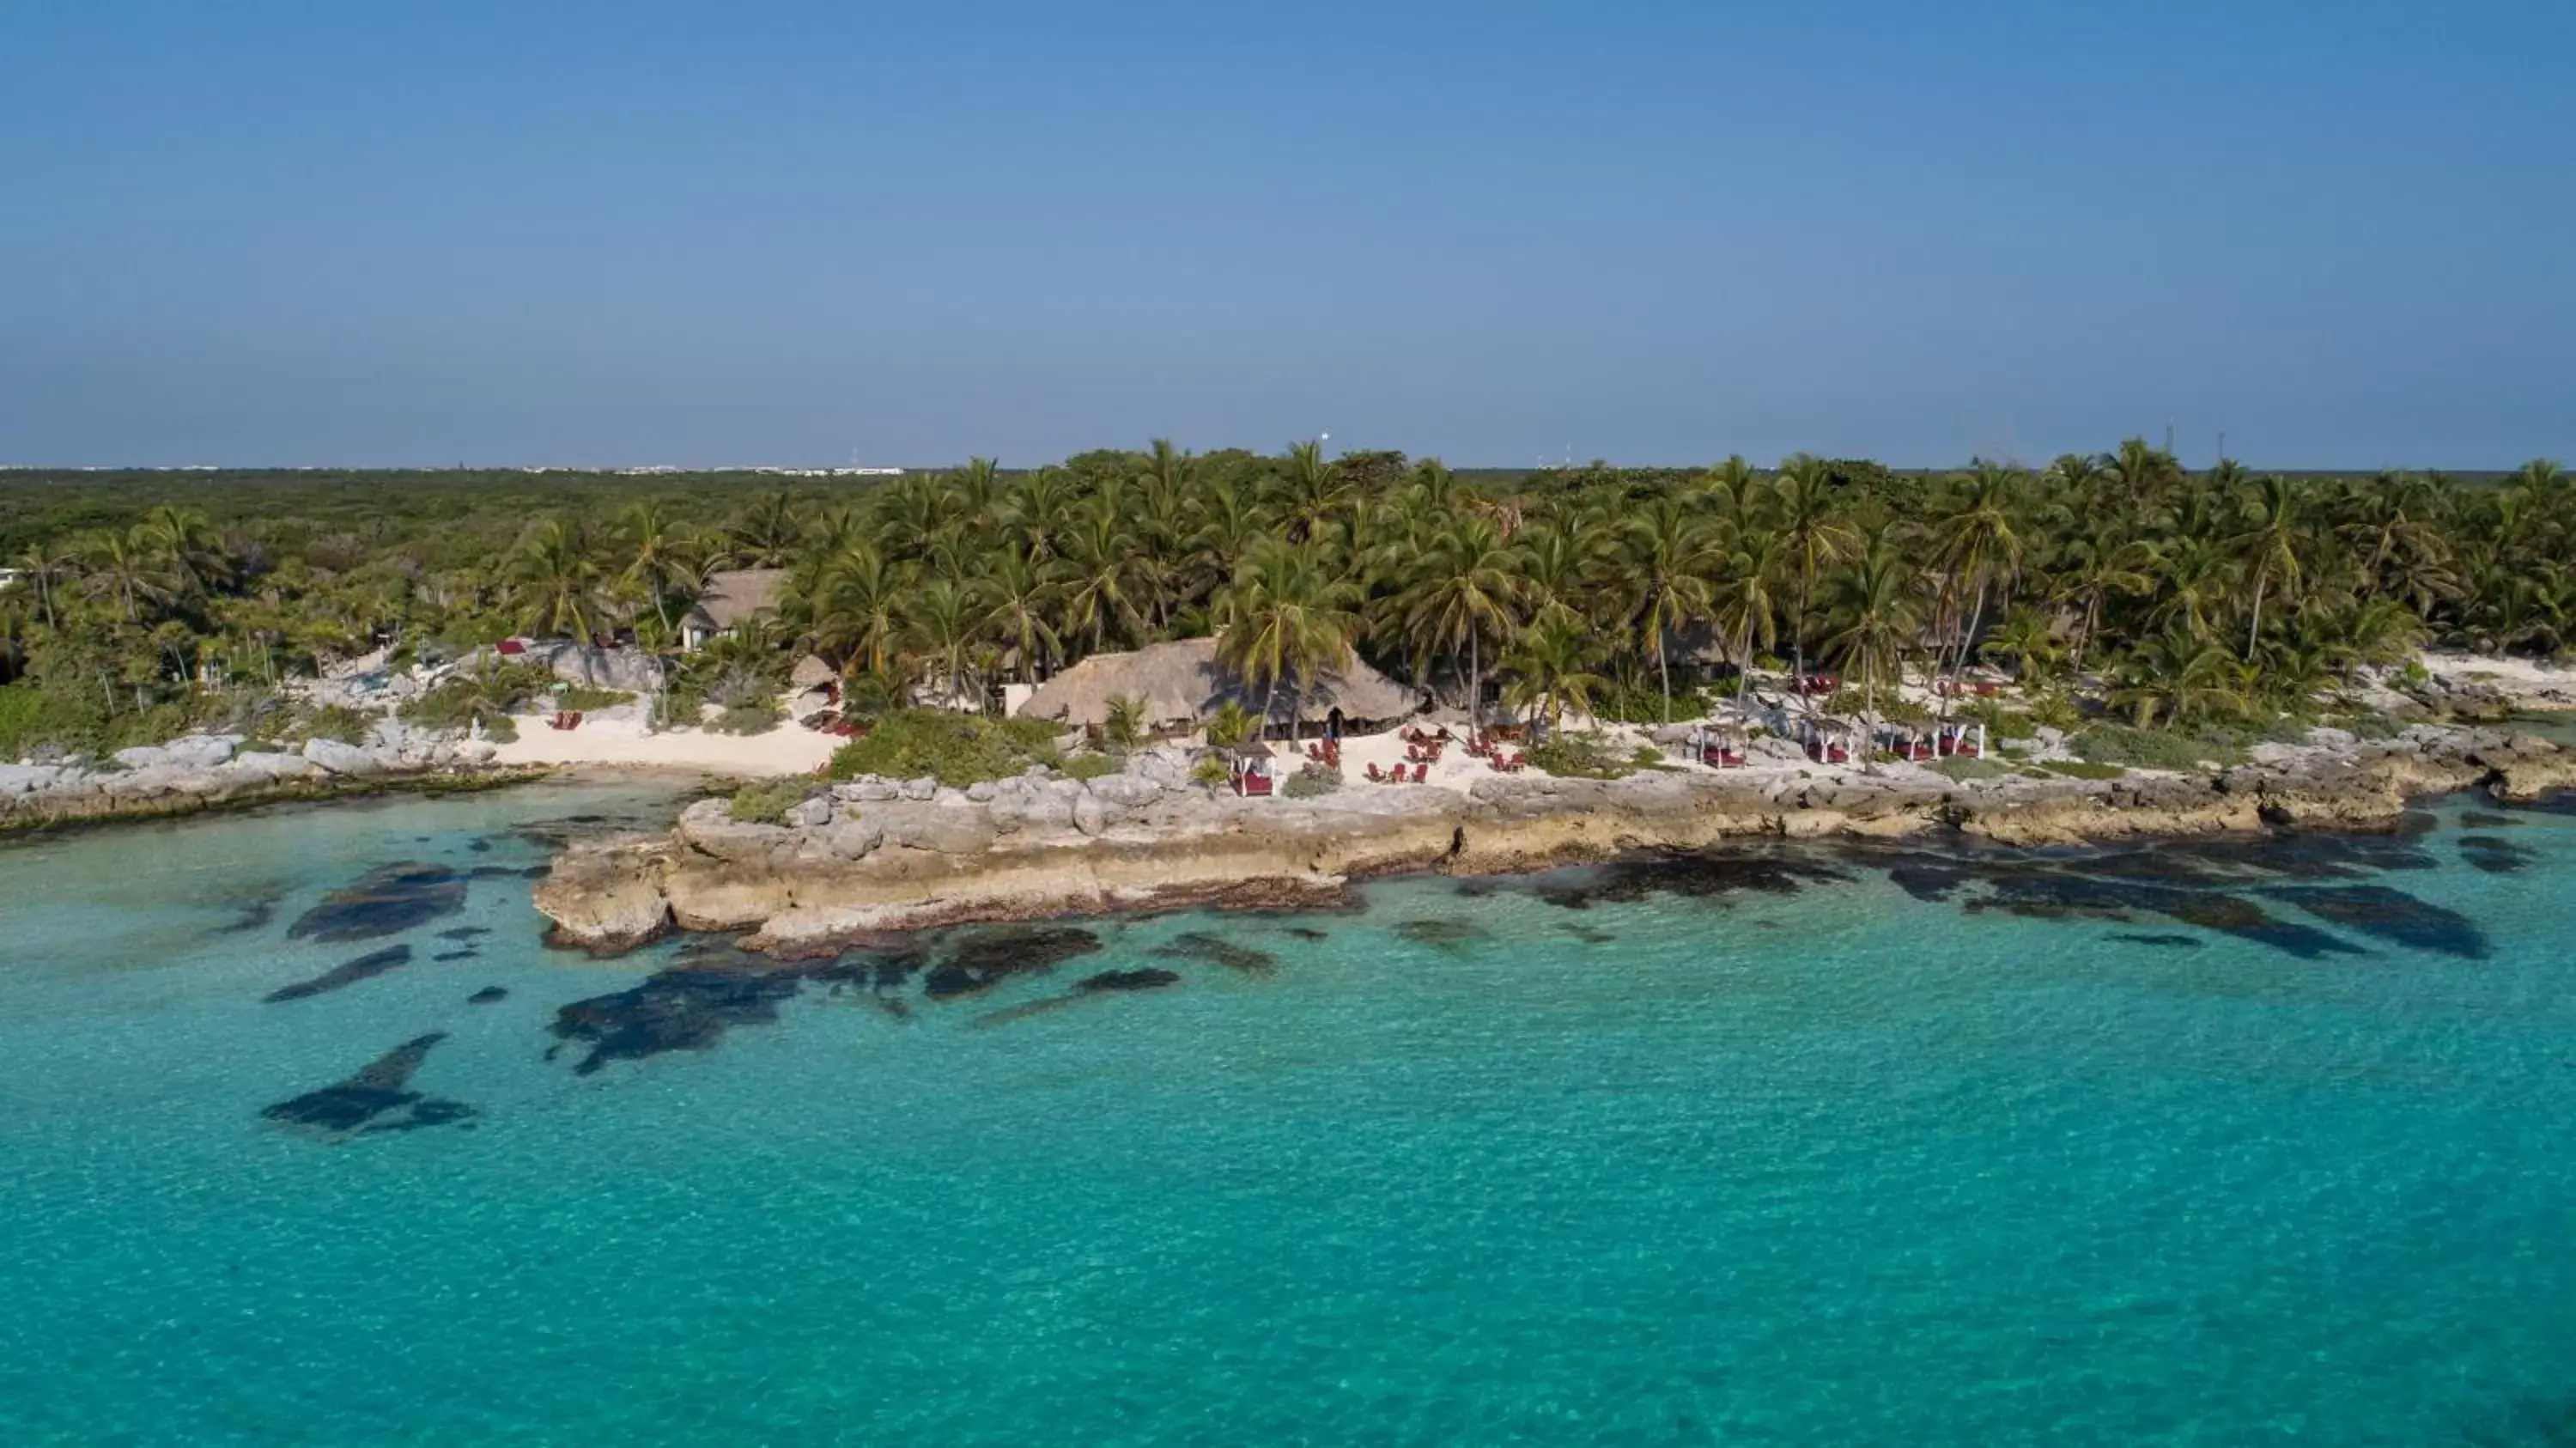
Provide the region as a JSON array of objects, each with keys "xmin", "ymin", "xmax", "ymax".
[{"xmin": 0, "ymin": 719, "xmax": 544, "ymax": 832}]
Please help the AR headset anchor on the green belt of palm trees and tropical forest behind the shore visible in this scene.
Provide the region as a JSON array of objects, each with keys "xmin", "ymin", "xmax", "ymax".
[{"xmin": 0, "ymin": 441, "xmax": 2576, "ymax": 757}]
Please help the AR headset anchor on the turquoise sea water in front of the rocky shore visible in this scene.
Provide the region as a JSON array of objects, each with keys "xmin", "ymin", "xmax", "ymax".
[{"xmin": 0, "ymin": 786, "xmax": 2576, "ymax": 1445}]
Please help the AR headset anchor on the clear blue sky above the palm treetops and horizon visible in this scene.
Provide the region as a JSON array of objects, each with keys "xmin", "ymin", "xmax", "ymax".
[{"xmin": 0, "ymin": 0, "xmax": 2576, "ymax": 466}]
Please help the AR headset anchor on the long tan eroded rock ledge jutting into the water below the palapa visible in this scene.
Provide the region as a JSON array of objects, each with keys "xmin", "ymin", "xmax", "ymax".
[{"xmin": 536, "ymin": 727, "xmax": 2576, "ymax": 956}]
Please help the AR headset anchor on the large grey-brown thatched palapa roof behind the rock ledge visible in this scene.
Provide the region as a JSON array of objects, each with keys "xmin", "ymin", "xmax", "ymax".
[{"xmin": 1020, "ymin": 639, "xmax": 1422, "ymax": 729}]
